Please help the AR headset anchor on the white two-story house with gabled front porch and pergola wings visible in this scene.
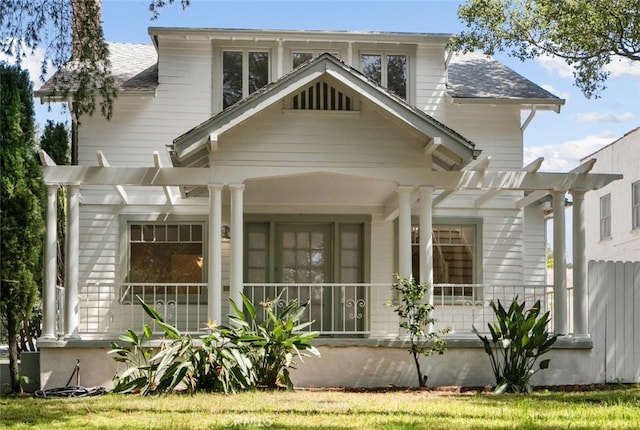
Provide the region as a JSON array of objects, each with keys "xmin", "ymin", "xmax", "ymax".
[{"xmin": 33, "ymin": 28, "xmax": 620, "ymax": 387}]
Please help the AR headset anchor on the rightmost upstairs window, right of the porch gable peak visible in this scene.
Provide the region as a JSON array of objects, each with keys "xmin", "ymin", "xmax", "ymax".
[{"xmin": 360, "ymin": 53, "xmax": 409, "ymax": 99}]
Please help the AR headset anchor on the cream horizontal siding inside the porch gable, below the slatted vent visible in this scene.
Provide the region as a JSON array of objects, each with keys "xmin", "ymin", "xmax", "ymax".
[{"xmin": 212, "ymin": 104, "xmax": 426, "ymax": 167}]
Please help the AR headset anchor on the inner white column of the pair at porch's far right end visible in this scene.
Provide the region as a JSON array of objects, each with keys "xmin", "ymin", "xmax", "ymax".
[{"xmin": 552, "ymin": 191, "xmax": 567, "ymax": 334}]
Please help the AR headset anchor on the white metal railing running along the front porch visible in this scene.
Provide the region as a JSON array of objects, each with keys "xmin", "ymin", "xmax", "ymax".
[{"xmin": 70, "ymin": 283, "xmax": 571, "ymax": 338}]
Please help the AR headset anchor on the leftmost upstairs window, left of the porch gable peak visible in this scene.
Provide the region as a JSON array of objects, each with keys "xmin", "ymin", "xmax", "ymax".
[{"xmin": 222, "ymin": 50, "xmax": 269, "ymax": 108}]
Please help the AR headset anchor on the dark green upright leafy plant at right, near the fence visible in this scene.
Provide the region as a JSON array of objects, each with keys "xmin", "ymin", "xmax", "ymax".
[{"xmin": 473, "ymin": 297, "xmax": 558, "ymax": 393}]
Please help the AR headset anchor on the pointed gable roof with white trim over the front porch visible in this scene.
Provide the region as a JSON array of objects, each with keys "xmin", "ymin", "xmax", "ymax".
[{"xmin": 169, "ymin": 53, "xmax": 480, "ymax": 170}]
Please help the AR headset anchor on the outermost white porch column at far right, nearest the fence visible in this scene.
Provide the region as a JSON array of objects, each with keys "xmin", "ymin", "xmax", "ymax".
[{"xmin": 571, "ymin": 191, "xmax": 589, "ymax": 335}]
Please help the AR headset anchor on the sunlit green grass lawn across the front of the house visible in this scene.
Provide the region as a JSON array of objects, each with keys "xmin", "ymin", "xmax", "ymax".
[{"xmin": 0, "ymin": 385, "xmax": 640, "ymax": 430}]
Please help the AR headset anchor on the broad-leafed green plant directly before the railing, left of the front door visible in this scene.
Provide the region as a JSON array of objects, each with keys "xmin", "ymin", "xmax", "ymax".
[{"xmin": 229, "ymin": 292, "xmax": 320, "ymax": 389}]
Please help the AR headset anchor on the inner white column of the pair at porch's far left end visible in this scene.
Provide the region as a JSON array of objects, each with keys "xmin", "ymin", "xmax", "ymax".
[{"xmin": 64, "ymin": 185, "xmax": 80, "ymax": 339}]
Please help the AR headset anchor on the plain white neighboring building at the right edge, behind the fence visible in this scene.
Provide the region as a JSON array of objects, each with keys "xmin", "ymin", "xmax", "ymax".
[{"xmin": 582, "ymin": 128, "xmax": 640, "ymax": 261}]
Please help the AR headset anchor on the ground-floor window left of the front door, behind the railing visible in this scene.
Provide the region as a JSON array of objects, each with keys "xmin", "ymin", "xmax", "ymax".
[{"xmin": 128, "ymin": 222, "xmax": 204, "ymax": 294}]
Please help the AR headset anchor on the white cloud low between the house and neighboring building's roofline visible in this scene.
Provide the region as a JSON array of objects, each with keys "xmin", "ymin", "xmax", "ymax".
[{"xmin": 524, "ymin": 132, "xmax": 616, "ymax": 172}]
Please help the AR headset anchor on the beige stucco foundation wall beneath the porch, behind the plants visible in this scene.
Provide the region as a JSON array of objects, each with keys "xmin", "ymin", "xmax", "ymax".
[{"xmin": 40, "ymin": 337, "xmax": 592, "ymax": 389}]
